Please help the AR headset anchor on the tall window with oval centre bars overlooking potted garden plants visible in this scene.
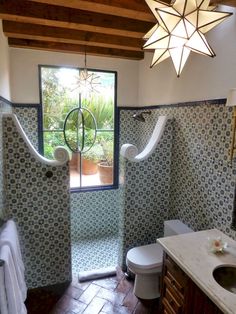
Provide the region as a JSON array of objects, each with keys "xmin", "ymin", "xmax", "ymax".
[{"xmin": 39, "ymin": 66, "xmax": 118, "ymax": 191}]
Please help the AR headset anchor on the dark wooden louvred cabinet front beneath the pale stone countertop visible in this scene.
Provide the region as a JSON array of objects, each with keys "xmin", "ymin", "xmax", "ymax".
[{"xmin": 161, "ymin": 253, "xmax": 223, "ymax": 314}]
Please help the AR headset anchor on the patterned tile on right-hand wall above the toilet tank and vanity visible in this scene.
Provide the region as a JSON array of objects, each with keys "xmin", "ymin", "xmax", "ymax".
[{"xmin": 167, "ymin": 101, "xmax": 236, "ymax": 238}]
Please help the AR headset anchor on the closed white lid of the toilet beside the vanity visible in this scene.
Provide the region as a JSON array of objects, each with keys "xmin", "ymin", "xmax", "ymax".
[{"xmin": 127, "ymin": 243, "xmax": 163, "ymax": 269}]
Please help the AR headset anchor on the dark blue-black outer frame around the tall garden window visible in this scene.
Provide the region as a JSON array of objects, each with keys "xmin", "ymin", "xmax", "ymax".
[{"xmin": 38, "ymin": 64, "xmax": 119, "ymax": 193}]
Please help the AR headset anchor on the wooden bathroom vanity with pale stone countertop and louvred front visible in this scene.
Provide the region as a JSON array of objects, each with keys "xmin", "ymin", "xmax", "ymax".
[{"xmin": 157, "ymin": 229, "xmax": 236, "ymax": 314}]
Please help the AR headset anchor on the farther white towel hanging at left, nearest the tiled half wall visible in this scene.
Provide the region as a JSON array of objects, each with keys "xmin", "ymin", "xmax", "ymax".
[{"xmin": 0, "ymin": 220, "xmax": 27, "ymax": 301}]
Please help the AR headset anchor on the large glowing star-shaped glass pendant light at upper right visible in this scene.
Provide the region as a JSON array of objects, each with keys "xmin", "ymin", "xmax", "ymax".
[{"xmin": 143, "ymin": 0, "xmax": 232, "ymax": 76}]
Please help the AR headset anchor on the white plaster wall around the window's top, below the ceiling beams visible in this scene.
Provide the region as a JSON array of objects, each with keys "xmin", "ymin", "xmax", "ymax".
[{"xmin": 10, "ymin": 48, "xmax": 139, "ymax": 106}]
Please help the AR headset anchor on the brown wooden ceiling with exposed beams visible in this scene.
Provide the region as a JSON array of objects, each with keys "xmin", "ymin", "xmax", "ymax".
[{"xmin": 0, "ymin": 0, "xmax": 236, "ymax": 60}]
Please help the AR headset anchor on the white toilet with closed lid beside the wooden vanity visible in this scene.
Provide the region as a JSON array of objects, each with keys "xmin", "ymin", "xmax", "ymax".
[{"xmin": 126, "ymin": 219, "xmax": 193, "ymax": 299}]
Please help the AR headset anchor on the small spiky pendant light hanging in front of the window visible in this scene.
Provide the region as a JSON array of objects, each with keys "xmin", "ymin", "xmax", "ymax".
[{"xmin": 76, "ymin": 50, "xmax": 100, "ymax": 94}]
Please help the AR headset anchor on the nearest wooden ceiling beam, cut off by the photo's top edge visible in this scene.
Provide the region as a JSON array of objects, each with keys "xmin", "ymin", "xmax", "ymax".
[{"xmin": 28, "ymin": 0, "xmax": 155, "ymax": 22}]
